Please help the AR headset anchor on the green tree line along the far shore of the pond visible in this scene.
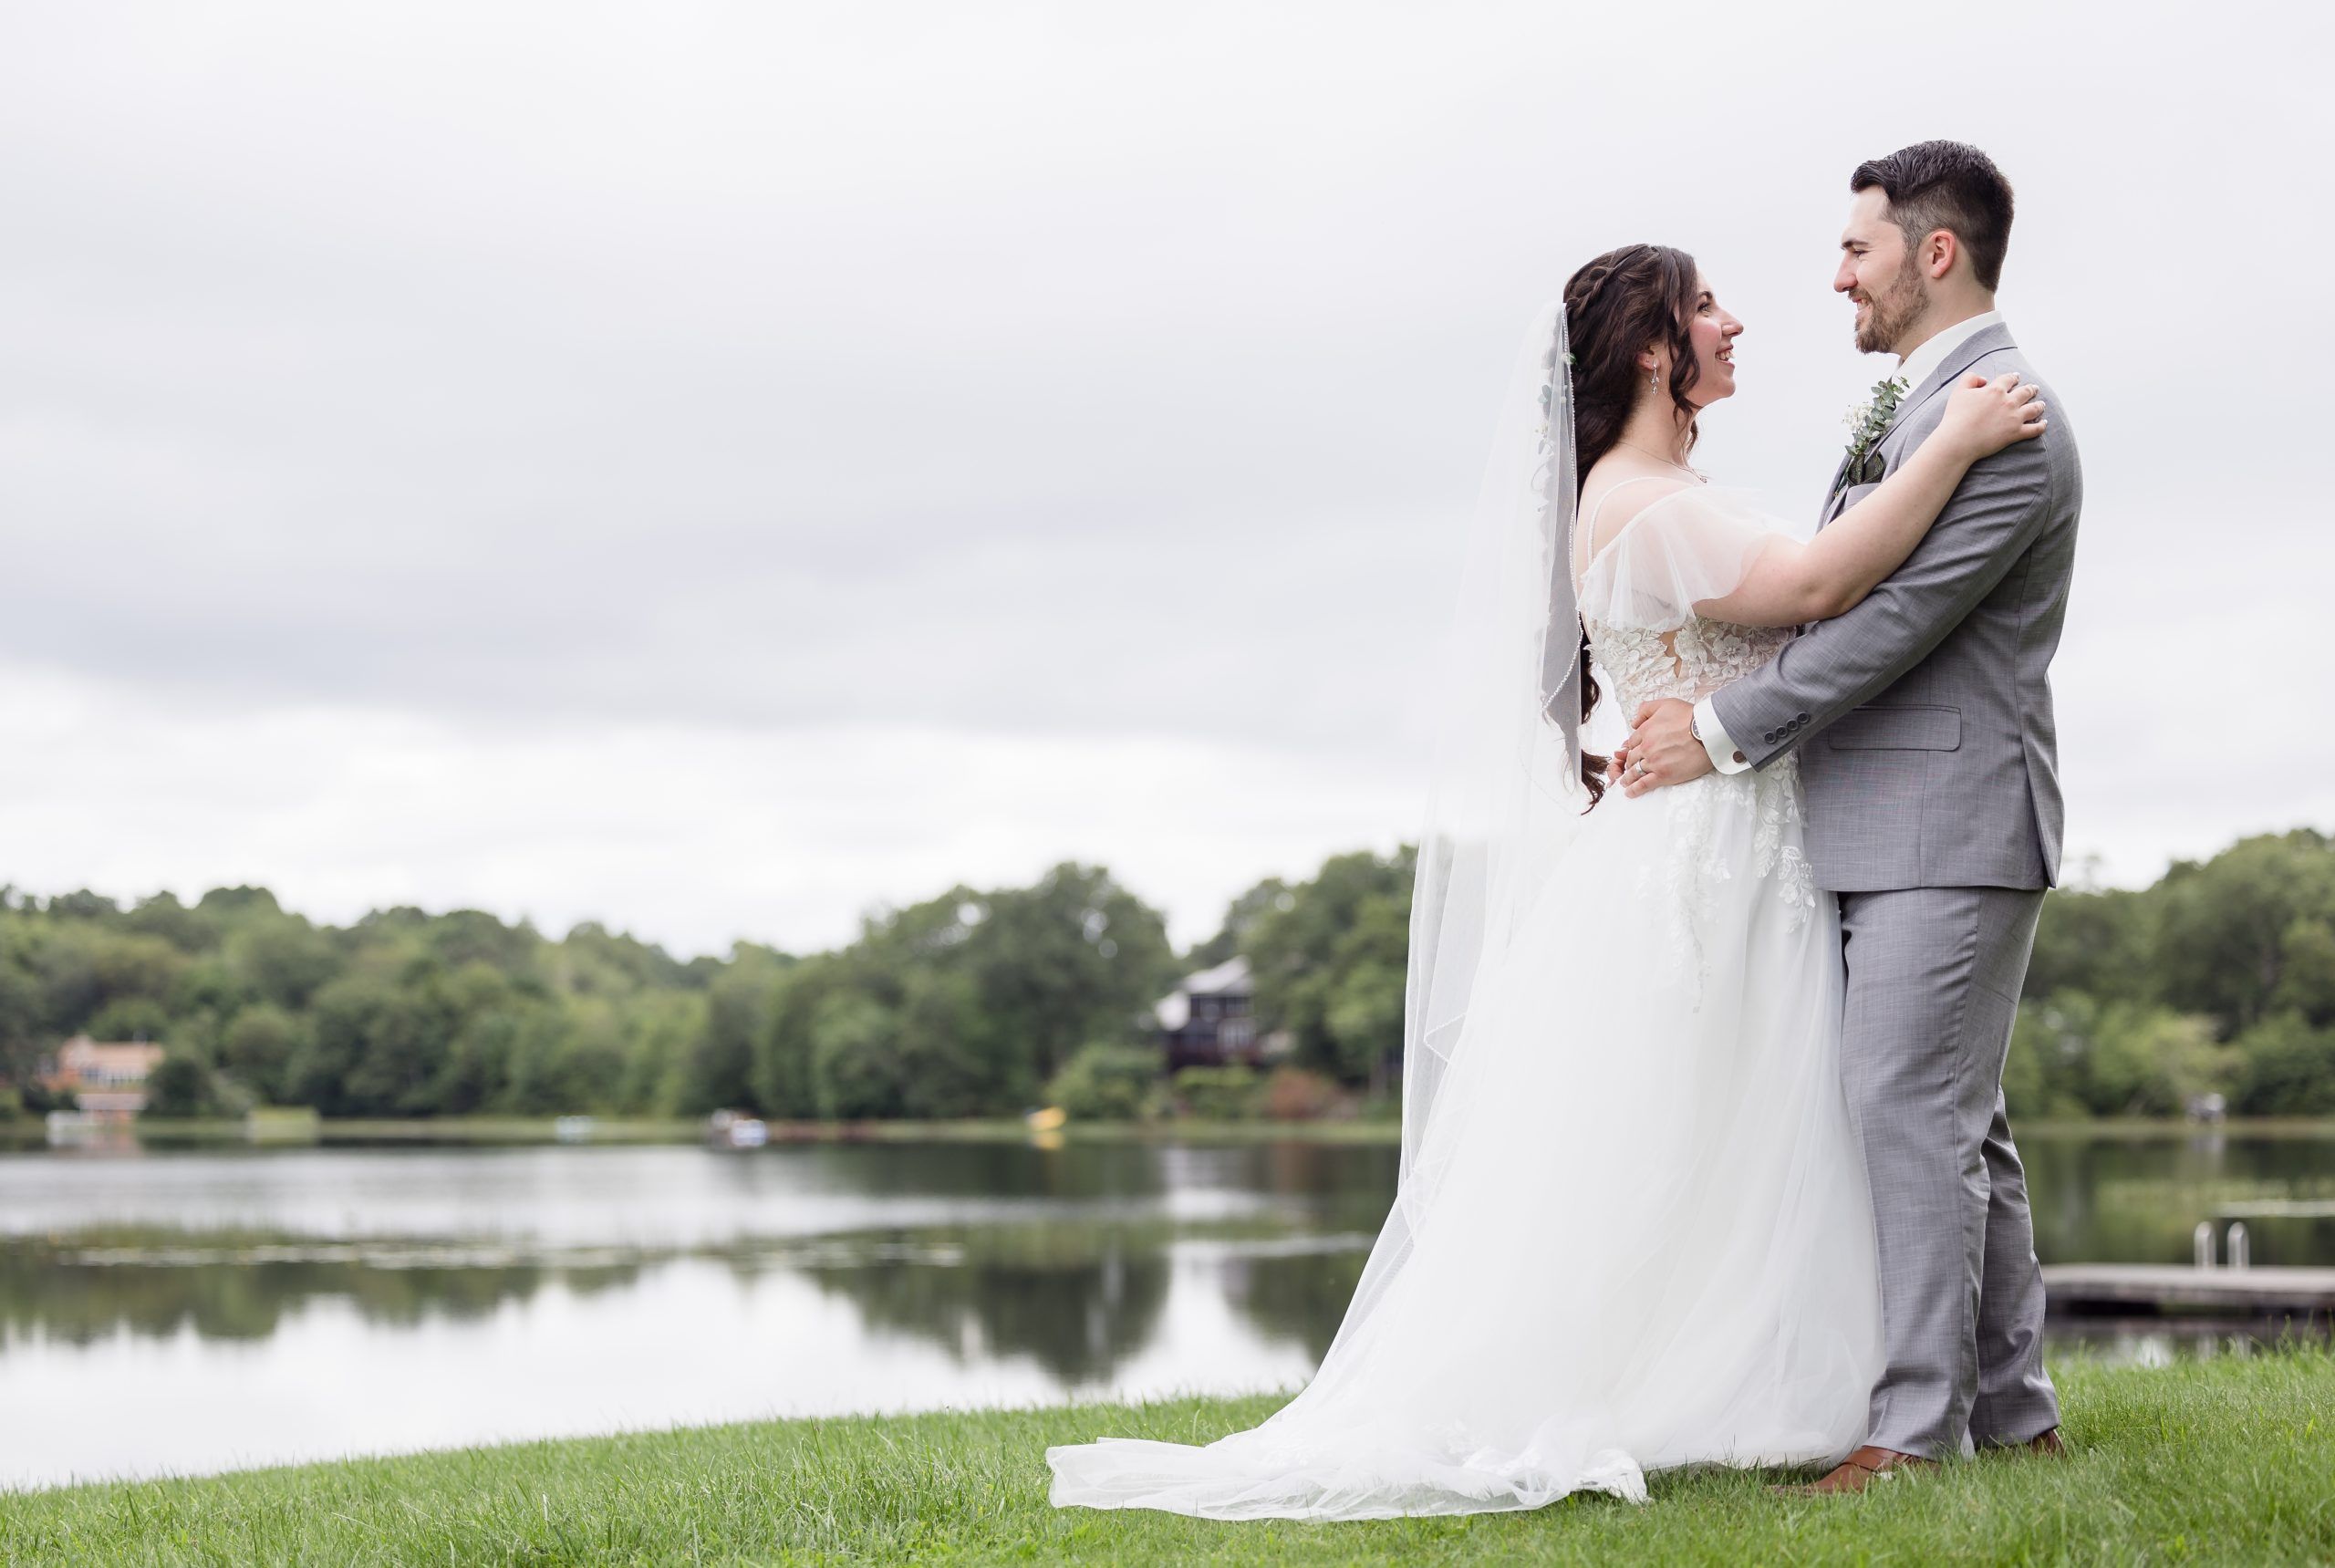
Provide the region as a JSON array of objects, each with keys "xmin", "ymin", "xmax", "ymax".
[{"xmin": 0, "ymin": 829, "xmax": 2335, "ymax": 1119}]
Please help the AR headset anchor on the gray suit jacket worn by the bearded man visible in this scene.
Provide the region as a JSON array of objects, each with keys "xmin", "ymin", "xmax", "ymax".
[{"xmin": 1711, "ymin": 323, "xmax": 2083, "ymax": 893}]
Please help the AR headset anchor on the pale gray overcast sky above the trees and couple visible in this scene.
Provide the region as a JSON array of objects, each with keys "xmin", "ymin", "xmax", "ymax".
[{"xmin": 0, "ymin": 0, "xmax": 2335, "ymax": 953}]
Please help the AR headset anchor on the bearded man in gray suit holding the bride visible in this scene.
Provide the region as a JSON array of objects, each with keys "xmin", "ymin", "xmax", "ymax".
[{"xmin": 1616, "ymin": 142, "xmax": 2083, "ymax": 1490}]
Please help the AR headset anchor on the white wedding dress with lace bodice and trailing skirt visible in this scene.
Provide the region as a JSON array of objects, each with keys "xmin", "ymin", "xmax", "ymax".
[{"xmin": 1046, "ymin": 479, "xmax": 1882, "ymax": 1519}]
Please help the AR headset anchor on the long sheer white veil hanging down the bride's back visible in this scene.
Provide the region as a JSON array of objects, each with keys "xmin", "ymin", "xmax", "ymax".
[{"xmin": 1326, "ymin": 301, "xmax": 1588, "ymax": 1360}]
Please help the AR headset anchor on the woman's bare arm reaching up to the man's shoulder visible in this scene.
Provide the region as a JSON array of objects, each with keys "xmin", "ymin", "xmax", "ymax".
[{"xmin": 1696, "ymin": 371, "xmax": 2046, "ymax": 627}]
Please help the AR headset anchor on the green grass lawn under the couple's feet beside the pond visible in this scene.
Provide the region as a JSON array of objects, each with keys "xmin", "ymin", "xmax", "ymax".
[{"xmin": 0, "ymin": 1351, "xmax": 2335, "ymax": 1563}]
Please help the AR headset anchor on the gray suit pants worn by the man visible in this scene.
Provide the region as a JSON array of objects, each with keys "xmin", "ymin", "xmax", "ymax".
[{"xmin": 1838, "ymin": 888, "xmax": 2060, "ymax": 1459}]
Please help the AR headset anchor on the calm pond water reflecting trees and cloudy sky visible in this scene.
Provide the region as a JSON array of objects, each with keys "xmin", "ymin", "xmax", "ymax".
[{"xmin": 0, "ymin": 1128, "xmax": 2335, "ymax": 1489}]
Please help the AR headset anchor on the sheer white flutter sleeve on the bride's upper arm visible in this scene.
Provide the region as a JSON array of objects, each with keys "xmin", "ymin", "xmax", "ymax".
[{"xmin": 1581, "ymin": 483, "xmax": 1798, "ymax": 631}]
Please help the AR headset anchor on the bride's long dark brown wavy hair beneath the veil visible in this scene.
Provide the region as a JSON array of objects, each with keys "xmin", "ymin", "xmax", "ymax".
[{"xmin": 1564, "ymin": 245, "xmax": 1702, "ymax": 806}]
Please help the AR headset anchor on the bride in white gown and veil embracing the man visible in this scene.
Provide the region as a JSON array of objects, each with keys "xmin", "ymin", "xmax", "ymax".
[{"xmin": 1046, "ymin": 245, "xmax": 2043, "ymax": 1519}]
